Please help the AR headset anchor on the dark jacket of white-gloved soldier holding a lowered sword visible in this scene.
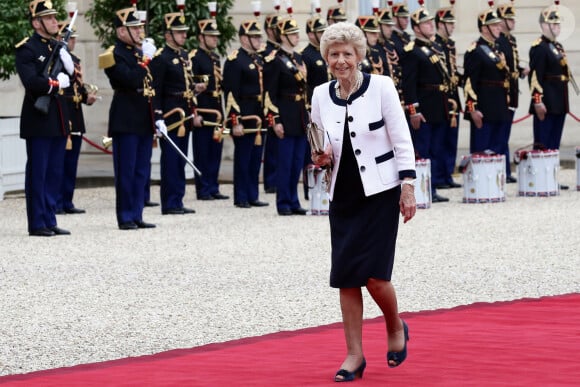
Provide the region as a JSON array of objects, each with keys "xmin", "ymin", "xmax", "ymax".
[{"xmin": 105, "ymin": 41, "xmax": 155, "ymax": 136}]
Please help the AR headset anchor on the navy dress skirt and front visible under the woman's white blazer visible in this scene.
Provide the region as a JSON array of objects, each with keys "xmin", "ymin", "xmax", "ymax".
[{"xmin": 329, "ymin": 121, "xmax": 401, "ymax": 288}]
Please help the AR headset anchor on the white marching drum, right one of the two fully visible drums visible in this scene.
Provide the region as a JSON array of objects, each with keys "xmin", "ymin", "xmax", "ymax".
[{"xmin": 515, "ymin": 149, "xmax": 560, "ymax": 196}]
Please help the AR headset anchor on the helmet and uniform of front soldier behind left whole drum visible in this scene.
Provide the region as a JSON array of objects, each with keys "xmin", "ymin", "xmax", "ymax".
[{"xmin": 463, "ymin": 10, "xmax": 511, "ymax": 154}]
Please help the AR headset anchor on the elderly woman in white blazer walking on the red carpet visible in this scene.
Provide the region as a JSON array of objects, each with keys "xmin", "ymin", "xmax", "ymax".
[{"xmin": 312, "ymin": 22, "xmax": 416, "ymax": 382}]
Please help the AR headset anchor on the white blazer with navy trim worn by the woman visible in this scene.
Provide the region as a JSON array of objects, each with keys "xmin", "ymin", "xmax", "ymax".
[{"xmin": 312, "ymin": 74, "xmax": 416, "ymax": 200}]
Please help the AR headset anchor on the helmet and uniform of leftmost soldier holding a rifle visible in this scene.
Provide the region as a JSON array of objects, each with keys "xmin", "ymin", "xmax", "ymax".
[{"xmin": 16, "ymin": 0, "xmax": 69, "ymax": 236}]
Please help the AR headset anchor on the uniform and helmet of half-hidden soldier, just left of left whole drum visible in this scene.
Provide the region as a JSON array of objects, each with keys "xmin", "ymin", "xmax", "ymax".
[{"xmin": 435, "ymin": 8, "xmax": 462, "ymax": 188}]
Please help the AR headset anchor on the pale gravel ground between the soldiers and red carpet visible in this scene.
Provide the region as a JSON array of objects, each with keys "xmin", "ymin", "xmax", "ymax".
[{"xmin": 0, "ymin": 169, "xmax": 580, "ymax": 375}]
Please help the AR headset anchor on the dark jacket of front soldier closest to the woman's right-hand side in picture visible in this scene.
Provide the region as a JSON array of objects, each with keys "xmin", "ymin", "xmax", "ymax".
[{"xmin": 401, "ymin": 39, "xmax": 449, "ymax": 124}]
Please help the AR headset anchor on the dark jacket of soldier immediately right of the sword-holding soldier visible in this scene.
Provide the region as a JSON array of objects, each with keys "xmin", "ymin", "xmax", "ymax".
[{"xmin": 149, "ymin": 45, "xmax": 195, "ymax": 129}]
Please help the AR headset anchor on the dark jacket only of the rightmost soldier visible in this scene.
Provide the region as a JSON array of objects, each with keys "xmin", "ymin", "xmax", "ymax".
[{"xmin": 529, "ymin": 36, "xmax": 570, "ymax": 114}]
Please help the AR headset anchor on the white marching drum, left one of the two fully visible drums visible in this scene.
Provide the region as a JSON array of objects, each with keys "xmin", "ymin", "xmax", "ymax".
[{"xmin": 459, "ymin": 153, "xmax": 506, "ymax": 203}]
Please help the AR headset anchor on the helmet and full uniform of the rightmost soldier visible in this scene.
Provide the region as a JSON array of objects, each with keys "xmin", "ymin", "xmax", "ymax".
[{"xmin": 528, "ymin": 7, "xmax": 570, "ymax": 149}]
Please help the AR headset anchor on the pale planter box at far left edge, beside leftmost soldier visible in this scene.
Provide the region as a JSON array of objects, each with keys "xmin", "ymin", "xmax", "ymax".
[{"xmin": 0, "ymin": 117, "xmax": 26, "ymax": 200}]
